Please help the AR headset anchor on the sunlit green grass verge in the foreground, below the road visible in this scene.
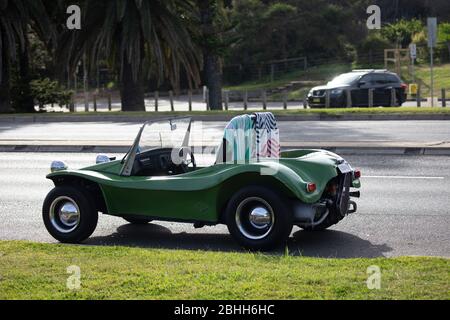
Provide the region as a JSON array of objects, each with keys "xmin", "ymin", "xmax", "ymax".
[{"xmin": 0, "ymin": 242, "xmax": 450, "ymax": 299}]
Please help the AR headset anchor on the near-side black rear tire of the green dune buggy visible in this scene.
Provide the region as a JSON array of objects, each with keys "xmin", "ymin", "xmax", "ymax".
[{"xmin": 225, "ymin": 186, "xmax": 293, "ymax": 251}]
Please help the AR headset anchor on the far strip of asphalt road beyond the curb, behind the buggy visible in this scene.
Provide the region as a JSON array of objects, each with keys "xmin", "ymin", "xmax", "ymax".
[{"xmin": 0, "ymin": 121, "xmax": 450, "ymax": 145}]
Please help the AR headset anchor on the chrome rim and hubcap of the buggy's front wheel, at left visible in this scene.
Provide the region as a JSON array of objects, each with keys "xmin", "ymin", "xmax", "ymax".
[{"xmin": 49, "ymin": 197, "xmax": 80, "ymax": 233}]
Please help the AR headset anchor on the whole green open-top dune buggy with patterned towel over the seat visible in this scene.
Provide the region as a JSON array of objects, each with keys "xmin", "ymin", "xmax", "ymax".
[{"xmin": 43, "ymin": 113, "xmax": 360, "ymax": 250}]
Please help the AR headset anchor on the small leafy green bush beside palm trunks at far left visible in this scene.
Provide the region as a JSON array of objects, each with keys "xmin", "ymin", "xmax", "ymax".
[{"xmin": 31, "ymin": 78, "xmax": 73, "ymax": 109}]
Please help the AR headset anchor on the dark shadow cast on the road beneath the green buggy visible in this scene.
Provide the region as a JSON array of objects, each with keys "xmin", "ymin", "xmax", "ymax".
[{"xmin": 86, "ymin": 224, "xmax": 392, "ymax": 258}]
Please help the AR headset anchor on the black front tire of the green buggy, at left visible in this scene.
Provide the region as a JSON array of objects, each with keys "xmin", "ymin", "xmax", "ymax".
[{"xmin": 42, "ymin": 186, "xmax": 98, "ymax": 243}]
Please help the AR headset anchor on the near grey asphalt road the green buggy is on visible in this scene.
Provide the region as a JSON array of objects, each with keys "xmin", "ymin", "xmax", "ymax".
[{"xmin": 0, "ymin": 153, "xmax": 450, "ymax": 258}]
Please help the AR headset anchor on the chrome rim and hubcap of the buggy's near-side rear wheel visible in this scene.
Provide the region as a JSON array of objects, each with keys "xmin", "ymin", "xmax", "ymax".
[{"xmin": 236, "ymin": 197, "xmax": 275, "ymax": 240}]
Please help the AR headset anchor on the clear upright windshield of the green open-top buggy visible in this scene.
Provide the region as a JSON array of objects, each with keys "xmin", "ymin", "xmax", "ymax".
[{"xmin": 139, "ymin": 118, "xmax": 191, "ymax": 152}]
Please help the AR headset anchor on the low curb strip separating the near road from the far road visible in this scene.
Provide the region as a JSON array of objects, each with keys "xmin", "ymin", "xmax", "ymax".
[{"xmin": 0, "ymin": 145, "xmax": 450, "ymax": 156}]
